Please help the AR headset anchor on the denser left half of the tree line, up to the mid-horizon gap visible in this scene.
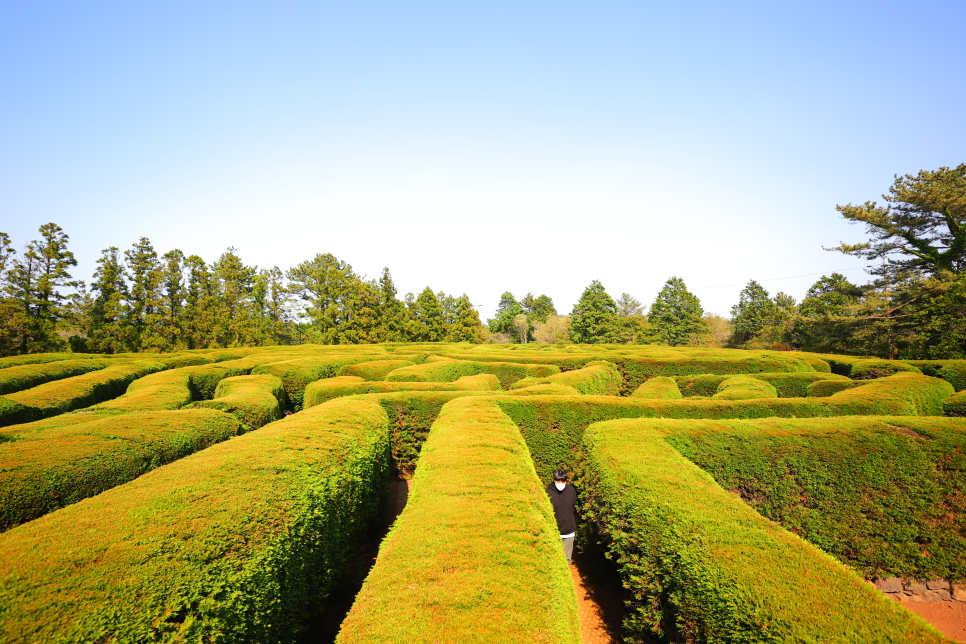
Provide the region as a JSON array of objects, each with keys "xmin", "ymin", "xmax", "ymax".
[{"xmin": 0, "ymin": 228, "xmax": 485, "ymax": 356}]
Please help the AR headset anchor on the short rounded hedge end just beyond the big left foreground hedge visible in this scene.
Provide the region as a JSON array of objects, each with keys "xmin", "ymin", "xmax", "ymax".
[{"xmin": 191, "ymin": 374, "xmax": 285, "ymax": 431}]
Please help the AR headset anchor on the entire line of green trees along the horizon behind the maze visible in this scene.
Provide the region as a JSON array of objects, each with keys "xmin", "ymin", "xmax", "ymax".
[{"xmin": 0, "ymin": 164, "xmax": 966, "ymax": 359}]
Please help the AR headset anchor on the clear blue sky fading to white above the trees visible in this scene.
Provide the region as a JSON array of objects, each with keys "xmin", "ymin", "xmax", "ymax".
[{"xmin": 0, "ymin": 0, "xmax": 966, "ymax": 317}]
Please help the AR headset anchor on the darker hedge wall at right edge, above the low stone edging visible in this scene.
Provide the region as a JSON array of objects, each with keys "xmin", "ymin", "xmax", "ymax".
[{"xmin": 654, "ymin": 416, "xmax": 966, "ymax": 580}]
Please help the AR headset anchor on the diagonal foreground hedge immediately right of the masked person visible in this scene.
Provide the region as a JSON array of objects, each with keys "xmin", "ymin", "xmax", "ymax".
[{"xmin": 575, "ymin": 420, "xmax": 948, "ymax": 644}]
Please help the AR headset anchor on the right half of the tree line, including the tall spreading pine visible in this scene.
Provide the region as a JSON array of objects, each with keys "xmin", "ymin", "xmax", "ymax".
[{"xmin": 489, "ymin": 164, "xmax": 966, "ymax": 359}]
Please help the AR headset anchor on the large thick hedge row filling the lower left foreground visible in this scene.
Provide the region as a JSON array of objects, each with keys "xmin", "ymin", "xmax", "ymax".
[{"xmin": 0, "ymin": 399, "xmax": 389, "ymax": 644}]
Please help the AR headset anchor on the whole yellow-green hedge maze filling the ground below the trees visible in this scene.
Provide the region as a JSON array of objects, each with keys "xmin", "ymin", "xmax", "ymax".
[{"xmin": 0, "ymin": 343, "xmax": 966, "ymax": 644}]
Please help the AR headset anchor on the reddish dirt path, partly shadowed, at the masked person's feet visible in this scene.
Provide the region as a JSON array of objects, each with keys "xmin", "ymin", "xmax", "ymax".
[{"xmin": 570, "ymin": 553, "xmax": 624, "ymax": 644}]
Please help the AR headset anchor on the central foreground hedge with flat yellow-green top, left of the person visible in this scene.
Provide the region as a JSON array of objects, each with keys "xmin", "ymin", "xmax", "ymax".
[{"xmin": 336, "ymin": 398, "xmax": 580, "ymax": 644}]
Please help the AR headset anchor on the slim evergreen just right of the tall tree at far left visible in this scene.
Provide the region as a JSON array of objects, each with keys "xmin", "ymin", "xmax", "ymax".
[{"xmin": 87, "ymin": 246, "xmax": 131, "ymax": 353}]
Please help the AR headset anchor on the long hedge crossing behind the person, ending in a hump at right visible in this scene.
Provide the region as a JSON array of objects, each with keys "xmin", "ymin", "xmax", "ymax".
[{"xmin": 498, "ymin": 373, "xmax": 952, "ymax": 480}]
